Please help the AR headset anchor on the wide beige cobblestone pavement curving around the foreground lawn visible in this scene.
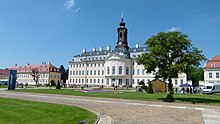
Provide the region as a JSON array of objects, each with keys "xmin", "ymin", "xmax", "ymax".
[{"xmin": 0, "ymin": 91, "xmax": 220, "ymax": 124}]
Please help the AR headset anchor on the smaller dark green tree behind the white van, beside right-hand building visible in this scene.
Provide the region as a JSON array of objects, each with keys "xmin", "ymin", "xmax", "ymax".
[{"xmin": 187, "ymin": 66, "xmax": 204, "ymax": 87}]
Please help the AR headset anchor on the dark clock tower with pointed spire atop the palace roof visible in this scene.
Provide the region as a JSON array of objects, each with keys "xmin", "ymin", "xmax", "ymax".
[{"xmin": 116, "ymin": 17, "xmax": 129, "ymax": 49}]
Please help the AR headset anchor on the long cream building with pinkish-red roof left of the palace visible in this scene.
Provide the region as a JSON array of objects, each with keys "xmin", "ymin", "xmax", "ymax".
[{"xmin": 10, "ymin": 63, "xmax": 61, "ymax": 85}]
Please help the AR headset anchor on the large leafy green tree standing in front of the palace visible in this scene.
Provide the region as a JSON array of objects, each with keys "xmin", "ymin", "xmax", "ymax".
[{"xmin": 137, "ymin": 32, "xmax": 206, "ymax": 100}]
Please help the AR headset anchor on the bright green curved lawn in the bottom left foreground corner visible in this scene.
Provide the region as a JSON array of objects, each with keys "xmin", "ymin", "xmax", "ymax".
[{"xmin": 0, "ymin": 98, "xmax": 97, "ymax": 124}]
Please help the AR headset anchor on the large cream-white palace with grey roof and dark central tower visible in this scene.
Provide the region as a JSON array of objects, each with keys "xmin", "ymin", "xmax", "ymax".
[{"xmin": 68, "ymin": 18, "xmax": 187, "ymax": 87}]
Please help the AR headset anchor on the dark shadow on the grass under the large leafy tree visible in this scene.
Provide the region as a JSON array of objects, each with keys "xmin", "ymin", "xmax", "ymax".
[{"xmin": 159, "ymin": 98, "xmax": 220, "ymax": 104}]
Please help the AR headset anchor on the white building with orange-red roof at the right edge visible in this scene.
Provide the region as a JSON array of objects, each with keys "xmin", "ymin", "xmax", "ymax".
[{"xmin": 204, "ymin": 55, "xmax": 220, "ymax": 85}]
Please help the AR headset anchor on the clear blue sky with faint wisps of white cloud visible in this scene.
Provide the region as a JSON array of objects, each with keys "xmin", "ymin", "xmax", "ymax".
[{"xmin": 0, "ymin": 0, "xmax": 220, "ymax": 68}]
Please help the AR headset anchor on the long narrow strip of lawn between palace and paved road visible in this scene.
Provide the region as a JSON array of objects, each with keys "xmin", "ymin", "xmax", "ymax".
[{"xmin": 13, "ymin": 89, "xmax": 220, "ymax": 105}]
